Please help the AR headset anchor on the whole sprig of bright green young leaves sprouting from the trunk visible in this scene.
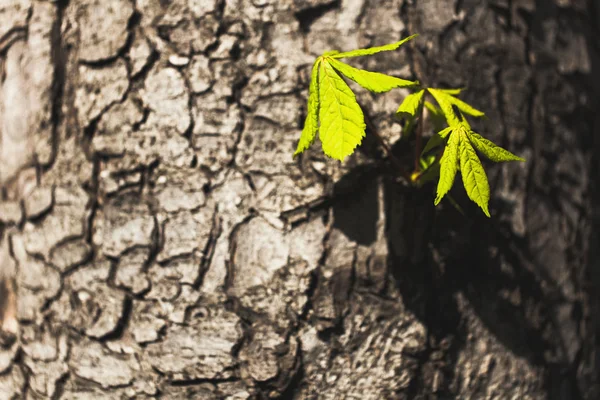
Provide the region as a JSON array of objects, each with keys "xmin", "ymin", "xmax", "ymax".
[{"xmin": 294, "ymin": 35, "xmax": 524, "ymax": 217}]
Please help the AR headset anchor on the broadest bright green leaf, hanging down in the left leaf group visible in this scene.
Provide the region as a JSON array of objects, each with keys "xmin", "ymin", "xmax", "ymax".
[{"xmin": 319, "ymin": 61, "xmax": 365, "ymax": 161}]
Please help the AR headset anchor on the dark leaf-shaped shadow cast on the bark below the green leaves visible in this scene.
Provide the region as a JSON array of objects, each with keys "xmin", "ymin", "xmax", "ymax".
[{"xmin": 333, "ymin": 167, "xmax": 582, "ymax": 398}]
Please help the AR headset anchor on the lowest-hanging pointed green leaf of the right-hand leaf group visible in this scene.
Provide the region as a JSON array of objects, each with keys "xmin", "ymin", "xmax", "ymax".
[{"xmin": 457, "ymin": 130, "xmax": 490, "ymax": 217}]
